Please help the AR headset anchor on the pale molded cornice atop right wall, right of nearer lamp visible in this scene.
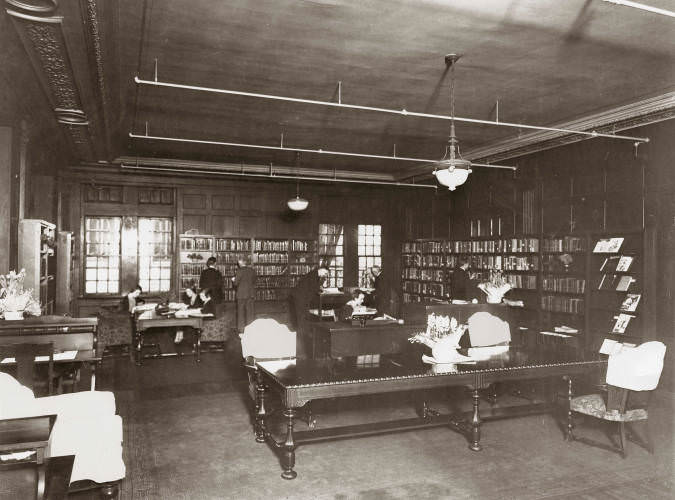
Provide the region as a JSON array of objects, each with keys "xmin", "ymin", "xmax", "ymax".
[{"xmin": 464, "ymin": 92, "xmax": 675, "ymax": 163}]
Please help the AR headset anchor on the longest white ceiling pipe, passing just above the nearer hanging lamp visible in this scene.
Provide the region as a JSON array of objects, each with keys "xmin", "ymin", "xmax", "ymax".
[{"xmin": 134, "ymin": 76, "xmax": 649, "ymax": 142}]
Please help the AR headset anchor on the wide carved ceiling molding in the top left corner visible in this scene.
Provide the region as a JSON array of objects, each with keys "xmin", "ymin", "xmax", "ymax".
[{"xmin": 5, "ymin": 0, "xmax": 95, "ymax": 160}]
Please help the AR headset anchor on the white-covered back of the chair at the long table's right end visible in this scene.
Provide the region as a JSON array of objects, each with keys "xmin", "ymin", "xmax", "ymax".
[{"xmin": 606, "ymin": 341, "xmax": 666, "ymax": 391}]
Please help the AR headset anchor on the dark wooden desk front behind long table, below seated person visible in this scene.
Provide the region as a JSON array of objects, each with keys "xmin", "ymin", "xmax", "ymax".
[{"xmin": 306, "ymin": 320, "xmax": 426, "ymax": 359}]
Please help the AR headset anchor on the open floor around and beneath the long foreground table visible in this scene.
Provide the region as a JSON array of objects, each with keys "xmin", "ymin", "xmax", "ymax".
[{"xmin": 11, "ymin": 344, "xmax": 674, "ymax": 500}]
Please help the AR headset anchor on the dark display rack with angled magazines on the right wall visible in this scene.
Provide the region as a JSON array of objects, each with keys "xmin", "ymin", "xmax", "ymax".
[{"xmin": 589, "ymin": 233, "xmax": 644, "ymax": 343}]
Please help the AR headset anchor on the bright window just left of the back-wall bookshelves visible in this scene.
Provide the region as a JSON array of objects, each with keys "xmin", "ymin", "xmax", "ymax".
[{"xmin": 138, "ymin": 217, "xmax": 173, "ymax": 292}]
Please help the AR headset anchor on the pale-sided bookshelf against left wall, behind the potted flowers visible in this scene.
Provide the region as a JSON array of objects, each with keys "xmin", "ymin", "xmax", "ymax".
[{"xmin": 18, "ymin": 219, "xmax": 56, "ymax": 314}]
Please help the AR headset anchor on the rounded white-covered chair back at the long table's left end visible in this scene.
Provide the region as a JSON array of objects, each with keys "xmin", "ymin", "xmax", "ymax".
[{"xmin": 241, "ymin": 318, "xmax": 296, "ymax": 360}]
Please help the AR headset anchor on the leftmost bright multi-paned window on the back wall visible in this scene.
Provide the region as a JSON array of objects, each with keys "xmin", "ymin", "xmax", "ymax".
[{"xmin": 84, "ymin": 217, "xmax": 122, "ymax": 293}]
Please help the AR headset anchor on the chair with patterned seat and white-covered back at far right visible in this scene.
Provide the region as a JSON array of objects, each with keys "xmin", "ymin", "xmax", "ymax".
[{"xmin": 567, "ymin": 342, "xmax": 666, "ymax": 458}]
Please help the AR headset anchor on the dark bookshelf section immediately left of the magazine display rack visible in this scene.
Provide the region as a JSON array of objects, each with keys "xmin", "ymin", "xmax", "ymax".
[{"xmin": 539, "ymin": 236, "xmax": 588, "ymax": 338}]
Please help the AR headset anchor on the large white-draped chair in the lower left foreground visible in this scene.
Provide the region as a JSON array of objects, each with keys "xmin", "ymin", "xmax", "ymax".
[{"xmin": 0, "ymin": 372, "xmax": 126, "ymax": 498}]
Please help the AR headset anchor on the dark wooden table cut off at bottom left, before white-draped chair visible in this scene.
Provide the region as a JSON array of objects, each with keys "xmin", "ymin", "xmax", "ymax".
[{"xmin": 0, "ymin": 415, "xmax": 56, "ymax": 500}]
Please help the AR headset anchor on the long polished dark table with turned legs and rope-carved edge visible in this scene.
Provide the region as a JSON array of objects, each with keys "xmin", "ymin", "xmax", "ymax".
[{"xmin": 255, "ymin": 345, "xmax": 606, "ymax": 479}]
